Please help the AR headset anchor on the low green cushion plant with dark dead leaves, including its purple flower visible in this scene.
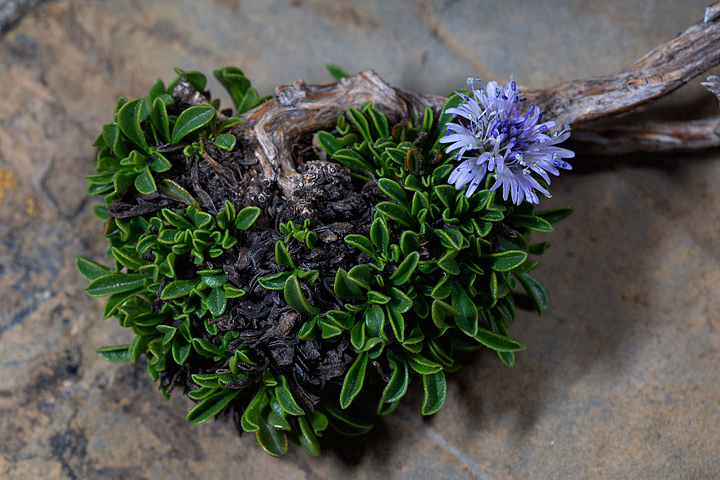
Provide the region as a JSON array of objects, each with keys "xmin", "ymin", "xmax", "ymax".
[{"xmin": 77, "ymin": 67, "xmax": 572, "ymax": 456}]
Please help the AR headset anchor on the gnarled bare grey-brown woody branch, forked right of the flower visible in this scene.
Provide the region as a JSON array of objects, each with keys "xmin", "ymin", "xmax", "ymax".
[{"xmin": 236, "ymin": 2, "xmax": 720, "ymax": 198}]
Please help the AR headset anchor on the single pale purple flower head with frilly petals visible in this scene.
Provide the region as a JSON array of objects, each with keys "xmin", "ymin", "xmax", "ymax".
[{"xmin": 440, "ymin": 78, "xmax": 575, "ymax": 205}]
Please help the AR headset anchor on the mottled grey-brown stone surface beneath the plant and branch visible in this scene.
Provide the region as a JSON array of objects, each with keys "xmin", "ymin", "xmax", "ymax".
[{"xmin": 0, "ymin": 0, "xmax": 720, "ymax": 480}]
